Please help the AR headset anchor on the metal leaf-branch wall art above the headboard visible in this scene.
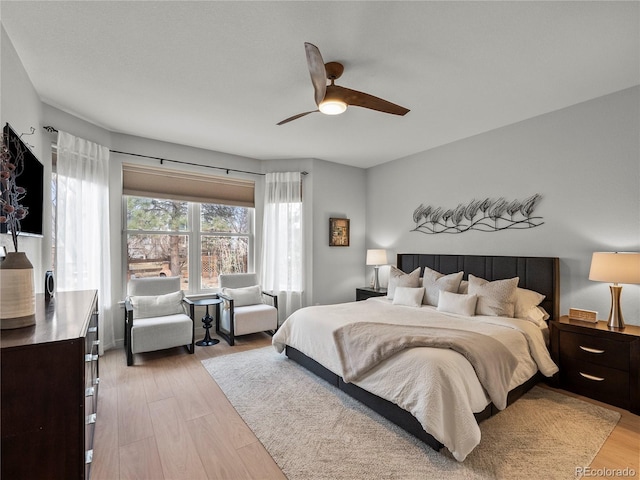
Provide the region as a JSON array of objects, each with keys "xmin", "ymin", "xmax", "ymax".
[{"xmin": 411, "ymin": 193, "xmax": 544, "ymax": 234}]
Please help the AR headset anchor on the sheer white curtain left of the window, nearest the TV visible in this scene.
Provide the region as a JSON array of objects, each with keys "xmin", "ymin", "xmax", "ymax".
[{"xmin": 55, "ymin": 132, "xmax": 115, "ymax": 353}]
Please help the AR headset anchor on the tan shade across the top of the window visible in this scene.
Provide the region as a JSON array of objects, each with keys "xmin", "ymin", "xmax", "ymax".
[{"xmin": 122, "ymin": 164, "xmax": 255, "ymax": 207}]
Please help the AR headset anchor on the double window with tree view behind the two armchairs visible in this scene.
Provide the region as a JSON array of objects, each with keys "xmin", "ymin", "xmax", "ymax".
[{"xmin": 123, "ymin": 195, "xmax": 253, "ymax": 292}]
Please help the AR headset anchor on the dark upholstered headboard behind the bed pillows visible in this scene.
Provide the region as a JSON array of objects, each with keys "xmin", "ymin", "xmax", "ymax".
[{"xmin": 397, "ymin": 253, "xmax": 560, "ymax": 319}]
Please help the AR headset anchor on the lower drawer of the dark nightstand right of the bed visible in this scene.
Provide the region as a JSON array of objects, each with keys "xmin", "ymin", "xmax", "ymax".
[{"xmin": 560, "ymin": 357, "xmax": 630, "ymax": 408}]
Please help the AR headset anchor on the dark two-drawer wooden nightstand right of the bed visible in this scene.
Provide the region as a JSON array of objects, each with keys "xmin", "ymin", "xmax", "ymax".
[{"xmin": 549, "ymin": 316, "xmax": 640, "ymax": 414}]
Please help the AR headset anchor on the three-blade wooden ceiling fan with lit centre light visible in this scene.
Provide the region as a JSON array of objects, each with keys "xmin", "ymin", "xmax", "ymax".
[{"xmin": 278, "ymin": 42, "xmax": 409, "ymax": 125}]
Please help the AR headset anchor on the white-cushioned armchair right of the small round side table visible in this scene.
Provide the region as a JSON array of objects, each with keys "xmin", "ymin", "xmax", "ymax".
[{"xmin": 216, "ymin": 273, "xmax": 278, "ymax": 346}]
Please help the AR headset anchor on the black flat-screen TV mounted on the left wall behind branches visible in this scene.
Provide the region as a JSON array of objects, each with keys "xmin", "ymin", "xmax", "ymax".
[{"xmin": 0, "ymin": 123, "xmax": 44, "ymax": 236}]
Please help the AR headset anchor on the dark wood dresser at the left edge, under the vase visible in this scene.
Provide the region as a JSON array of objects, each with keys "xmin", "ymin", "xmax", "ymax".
[{"xmin": 0, "ymin": 290, "xmax": 99, "ymax": 480}]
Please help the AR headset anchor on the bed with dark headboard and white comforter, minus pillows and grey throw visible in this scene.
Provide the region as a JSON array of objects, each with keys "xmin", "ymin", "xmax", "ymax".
[{"xmin": 273, "ymin": 254, "xmax": 559, "ymax": 461}]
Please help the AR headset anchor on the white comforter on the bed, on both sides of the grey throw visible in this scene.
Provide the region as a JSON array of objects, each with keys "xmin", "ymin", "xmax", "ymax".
[{"xmin": 273, "ymin": 297, "xmax": 558, "ymax": 461}]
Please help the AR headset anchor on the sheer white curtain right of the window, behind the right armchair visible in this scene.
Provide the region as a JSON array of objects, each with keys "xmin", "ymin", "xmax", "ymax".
[{"xmin": 262, "ymin": 172, "xmax": 304, "ymax": 323}]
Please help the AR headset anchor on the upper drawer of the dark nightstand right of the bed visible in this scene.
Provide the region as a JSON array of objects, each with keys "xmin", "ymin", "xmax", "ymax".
[{"xmin": 560, "ymin": 332, "xmax": 630, "ymax": 372}]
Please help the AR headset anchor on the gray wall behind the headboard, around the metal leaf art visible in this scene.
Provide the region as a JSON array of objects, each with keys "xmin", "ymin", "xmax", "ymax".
[{"xmin": 367, "ymin": 87, "xmax": 640, "ymax": 325}]
